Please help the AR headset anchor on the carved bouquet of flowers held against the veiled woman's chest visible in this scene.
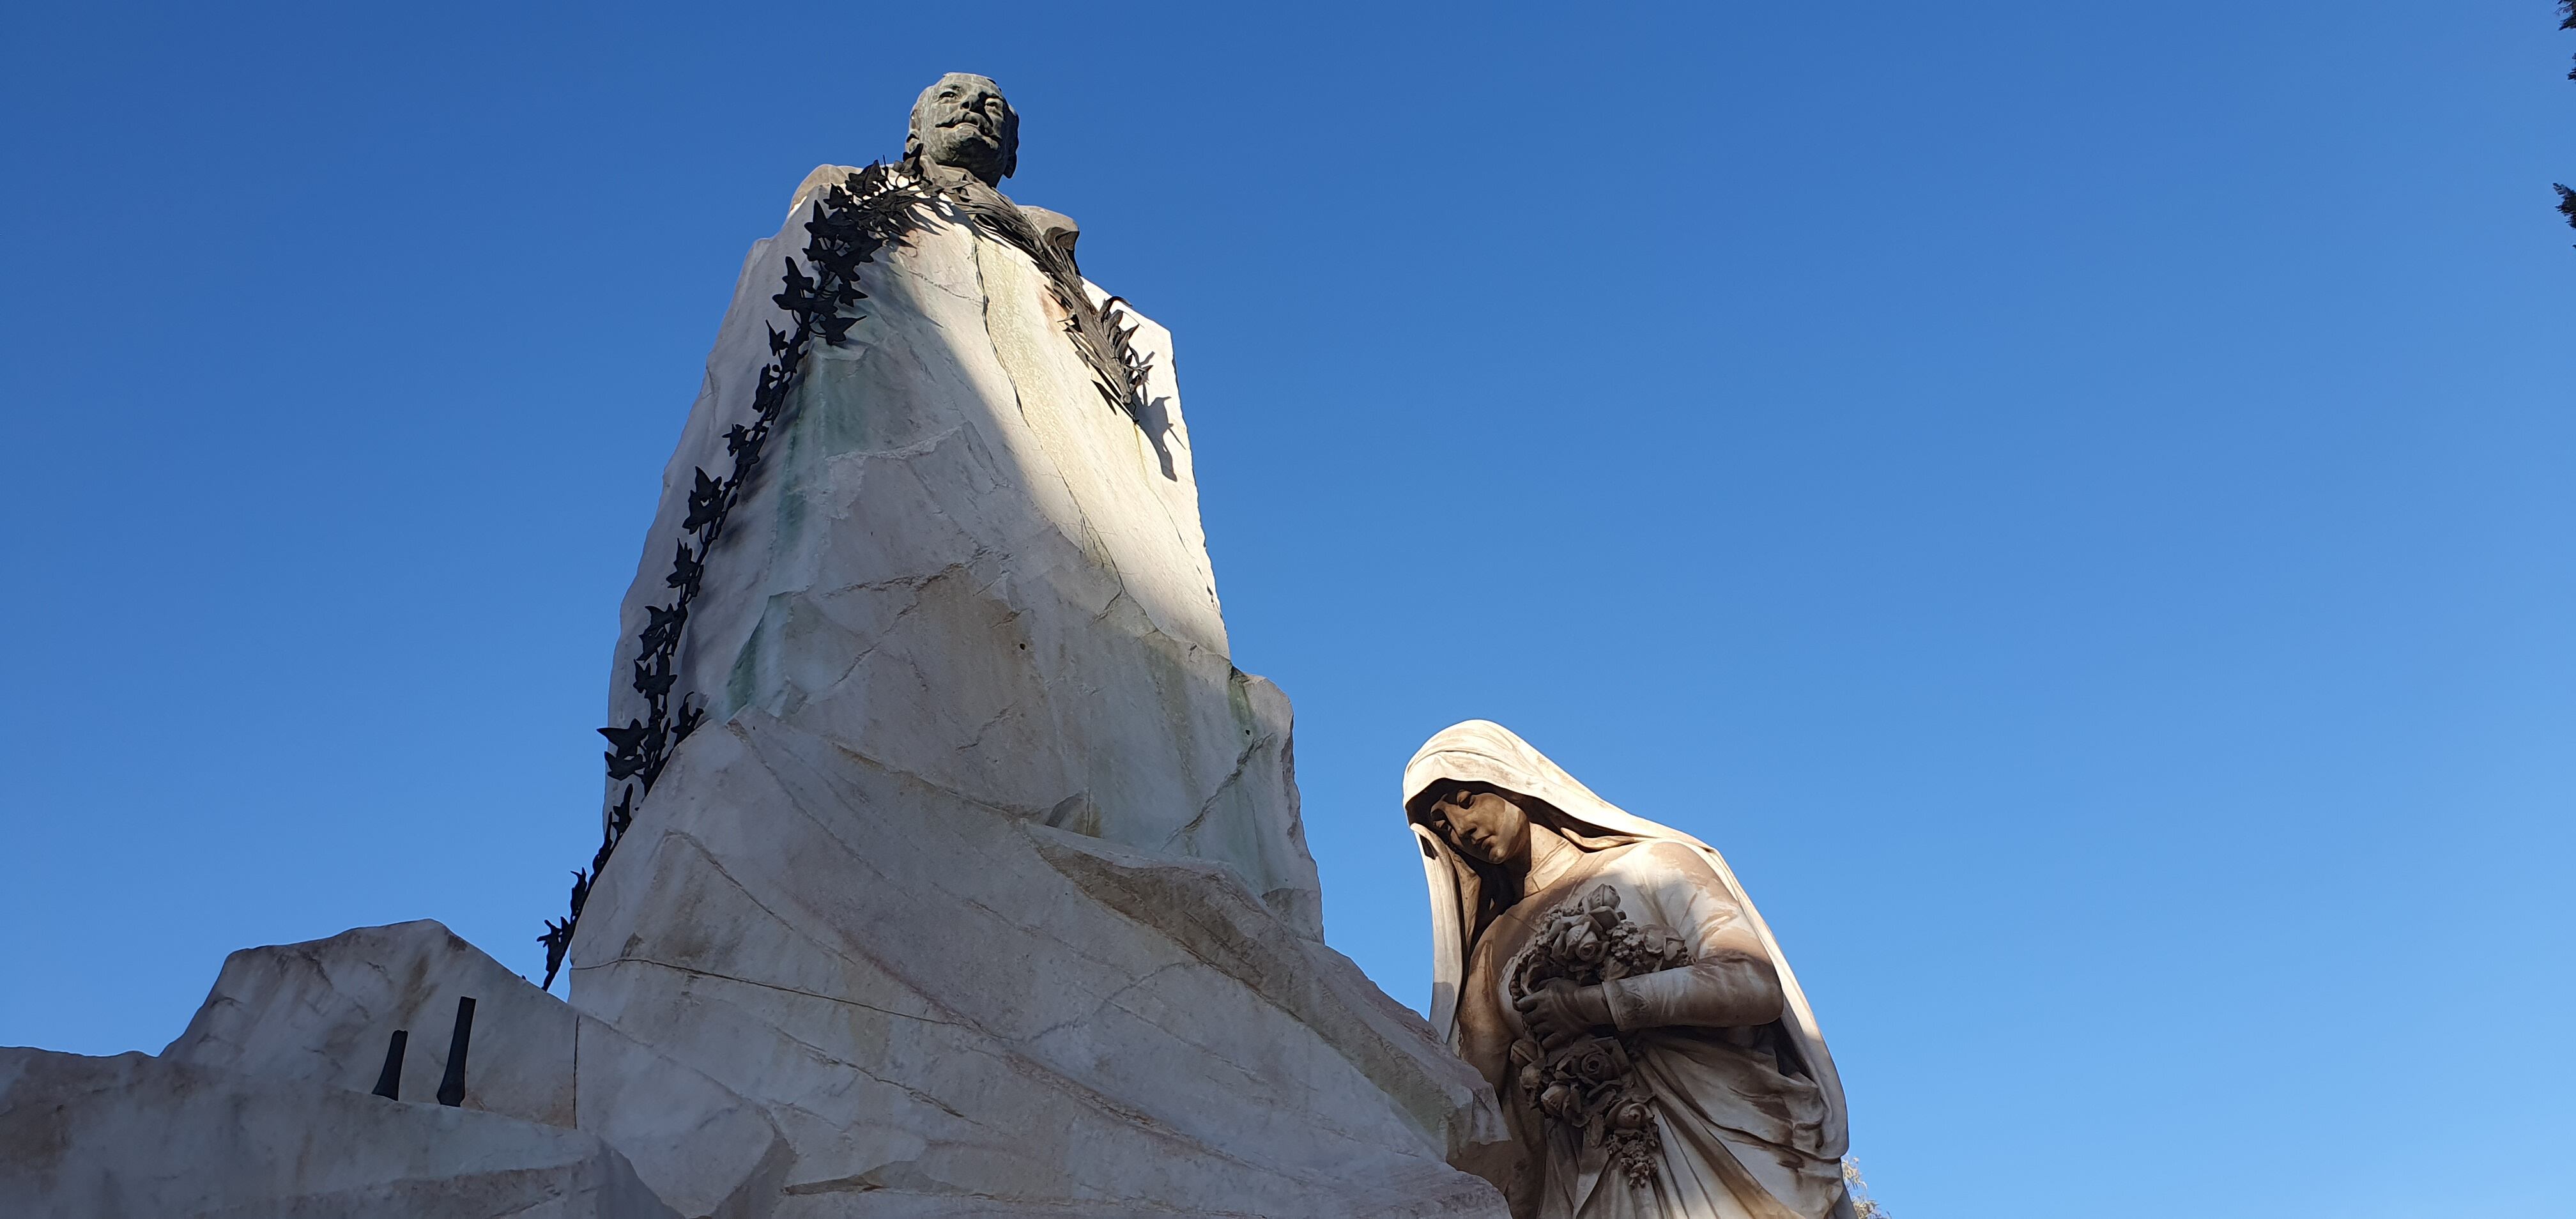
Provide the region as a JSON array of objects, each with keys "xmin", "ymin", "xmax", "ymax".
[{"xmin": 1507, "ymin": 884, "xmax": 1690, "ymax": 1186}]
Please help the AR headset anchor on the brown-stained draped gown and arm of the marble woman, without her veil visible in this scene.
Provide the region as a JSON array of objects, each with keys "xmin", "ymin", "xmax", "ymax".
[{"xmin": 1458, "ymin": 843, "xmax": 1842, "ymax": 1219}]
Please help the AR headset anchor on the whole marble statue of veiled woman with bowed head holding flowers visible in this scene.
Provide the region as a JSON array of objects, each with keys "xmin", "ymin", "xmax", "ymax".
[{"xmin": 1404, "ymin": 719, "xmax": 1852, "ymax": 1219}]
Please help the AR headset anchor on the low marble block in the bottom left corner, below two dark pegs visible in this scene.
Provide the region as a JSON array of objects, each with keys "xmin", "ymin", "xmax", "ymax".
[{"xmin": 0, "ymin": 1049, "xmax": 675, "ymax": 1219}]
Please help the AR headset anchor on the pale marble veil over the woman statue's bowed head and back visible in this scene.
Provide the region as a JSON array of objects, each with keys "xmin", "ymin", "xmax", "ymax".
[{"xmin": 1404, "ymin": 719, "xmax": 1844, "ymax": 1147}]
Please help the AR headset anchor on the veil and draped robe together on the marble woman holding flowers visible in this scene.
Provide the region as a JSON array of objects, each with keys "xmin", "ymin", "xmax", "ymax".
[{"xmin": 1404, "ymin": 719, "xmax": 1852, "ymax": 1219}]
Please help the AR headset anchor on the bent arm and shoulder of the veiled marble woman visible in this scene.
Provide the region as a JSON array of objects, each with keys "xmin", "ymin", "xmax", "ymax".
[{"xmin": 1602, "ymin": 843, "xmax": 1785, "ymax": 1034}]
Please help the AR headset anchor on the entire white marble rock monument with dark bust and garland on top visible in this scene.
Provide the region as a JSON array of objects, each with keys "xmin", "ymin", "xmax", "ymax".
[{"xmin": 0, "ymin": 75, "xmax": 1510, "ymax": 1219}]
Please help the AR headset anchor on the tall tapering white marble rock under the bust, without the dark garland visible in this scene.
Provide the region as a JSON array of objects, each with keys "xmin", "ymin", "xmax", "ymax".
[{"xmin": 569, "ymin": 157, "xmax": 1502, "ymax": 1216}]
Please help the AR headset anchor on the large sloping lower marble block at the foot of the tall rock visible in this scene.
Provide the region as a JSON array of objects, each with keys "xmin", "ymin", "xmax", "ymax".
[{"xmin": 572, "ymin": 711, "xmax": 1505, "ymax": 1216}]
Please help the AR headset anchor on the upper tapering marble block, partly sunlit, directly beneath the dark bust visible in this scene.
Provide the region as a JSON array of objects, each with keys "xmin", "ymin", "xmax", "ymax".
[{"xmin": 608, "ymin": 170, "xmax": 1321, "ymax": 938}]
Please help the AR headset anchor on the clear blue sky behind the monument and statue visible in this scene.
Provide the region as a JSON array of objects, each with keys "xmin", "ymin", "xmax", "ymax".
[{"xmin": 0, "ymin": 0, "xmax": 2576, "ymax": 1219}]
